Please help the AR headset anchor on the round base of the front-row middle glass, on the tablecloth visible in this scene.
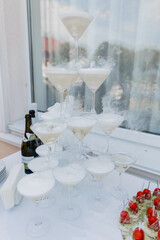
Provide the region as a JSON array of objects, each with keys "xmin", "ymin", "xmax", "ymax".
[{"xmin": 60, "ymin": 204, "xmax": 81, "ymax": 221}]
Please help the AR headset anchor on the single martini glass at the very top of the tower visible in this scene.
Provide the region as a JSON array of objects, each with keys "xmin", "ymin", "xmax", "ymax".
[{"xmin": 60, "ymin": 11, "xmax": 93, "ymax": 67}]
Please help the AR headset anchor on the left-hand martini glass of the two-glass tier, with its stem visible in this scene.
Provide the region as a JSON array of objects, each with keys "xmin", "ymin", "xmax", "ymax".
[{"xmin": 44, "ymin": 68, "xmax": 78, "ymax": 119}]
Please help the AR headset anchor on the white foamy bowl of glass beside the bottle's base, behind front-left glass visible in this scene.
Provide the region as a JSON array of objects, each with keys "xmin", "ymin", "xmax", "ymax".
[{"xmin": 28, "ymin": 157, "xmax": 58, "ymax": 172}]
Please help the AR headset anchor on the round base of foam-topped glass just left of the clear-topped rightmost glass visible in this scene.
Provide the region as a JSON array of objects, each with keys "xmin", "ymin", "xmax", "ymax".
[{"xmin": 88, "ymin": 195, "xmax": 109, "ymax": 212}]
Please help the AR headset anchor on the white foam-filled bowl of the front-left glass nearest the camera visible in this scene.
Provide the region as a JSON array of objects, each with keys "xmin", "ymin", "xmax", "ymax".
[{"xmin": 17, "ymin": 172, "xmax": 55, "ymax": 200}]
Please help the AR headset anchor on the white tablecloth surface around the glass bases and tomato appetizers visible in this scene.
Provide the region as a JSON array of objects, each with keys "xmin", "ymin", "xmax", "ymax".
[{"xmin": 0, "ymin": 152, "xmax": 155, "ymax": 240}]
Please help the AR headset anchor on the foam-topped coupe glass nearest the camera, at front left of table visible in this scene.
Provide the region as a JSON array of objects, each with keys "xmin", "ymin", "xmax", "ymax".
[{"xmin": 17, "ymin": 173, "xmax": 55, "ymax": 237}]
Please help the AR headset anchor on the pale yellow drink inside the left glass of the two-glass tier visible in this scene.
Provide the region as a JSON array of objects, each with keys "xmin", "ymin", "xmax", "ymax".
[{"xmin": 45, "ymin": 70, "xmax": 78, "ymax": 92}]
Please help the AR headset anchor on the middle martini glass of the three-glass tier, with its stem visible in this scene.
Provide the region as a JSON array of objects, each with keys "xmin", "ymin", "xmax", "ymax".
[{"xmin": 67, "ymin": 117, "xmax": 96, "ymax": 163}]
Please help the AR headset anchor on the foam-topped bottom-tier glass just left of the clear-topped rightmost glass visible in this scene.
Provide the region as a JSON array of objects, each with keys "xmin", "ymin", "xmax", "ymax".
[{"xmin": 86, "ymin": 155, "xmax": 114, "ymax": 211}]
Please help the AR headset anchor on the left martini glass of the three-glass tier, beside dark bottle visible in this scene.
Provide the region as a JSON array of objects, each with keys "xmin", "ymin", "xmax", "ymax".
[{"xmin": 31, "ymin": 121, "xmax": 66, "ymax": 169}]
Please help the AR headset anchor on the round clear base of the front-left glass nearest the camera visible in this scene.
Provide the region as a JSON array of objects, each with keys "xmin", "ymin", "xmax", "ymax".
[{"xmin": 27, "ymin": 217, "xmax": 51, "ymax": 238}]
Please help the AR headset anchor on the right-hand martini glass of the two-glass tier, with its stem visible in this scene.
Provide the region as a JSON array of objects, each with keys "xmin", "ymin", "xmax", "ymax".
[{"xmin": 79, "ymin": 68, "xmax": 111, "ymax": 114}]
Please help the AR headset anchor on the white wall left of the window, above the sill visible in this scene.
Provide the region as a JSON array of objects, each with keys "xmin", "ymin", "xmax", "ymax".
[{"xmin": 0, "ymin": 0, "xmax": 30, "ymax": 131}]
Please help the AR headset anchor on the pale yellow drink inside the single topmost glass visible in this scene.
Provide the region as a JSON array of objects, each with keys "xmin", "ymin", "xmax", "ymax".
[{"xmin": 61, "ymin": 14, "xmax": 92, "ymax": 38}]
